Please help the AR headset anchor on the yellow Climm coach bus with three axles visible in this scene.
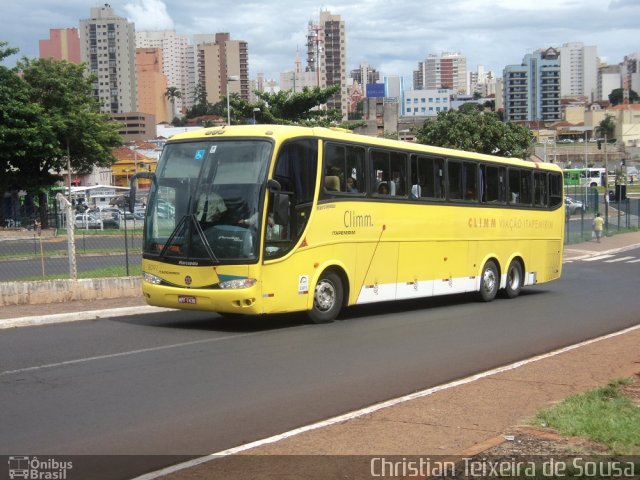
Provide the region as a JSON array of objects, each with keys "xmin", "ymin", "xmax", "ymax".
[{"xmin": 130, "ymin": 125, "xmax": 564, "ymax": 323}]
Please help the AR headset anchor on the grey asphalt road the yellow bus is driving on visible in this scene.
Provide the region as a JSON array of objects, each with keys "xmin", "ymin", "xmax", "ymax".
[{"xmin": 0, "ymin": 249, "xmax": 640, "ymax": 478}]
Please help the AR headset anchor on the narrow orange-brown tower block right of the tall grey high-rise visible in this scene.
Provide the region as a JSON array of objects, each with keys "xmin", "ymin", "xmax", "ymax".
[{"xmin": 136, "ymin": 48, "xmax": 169, "ymax": 123}]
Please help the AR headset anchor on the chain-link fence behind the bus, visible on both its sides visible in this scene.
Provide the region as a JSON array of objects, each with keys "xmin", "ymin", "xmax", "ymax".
[{"xmin": 0, "ymin": 193, "xmax": 640, "ymax": 282}]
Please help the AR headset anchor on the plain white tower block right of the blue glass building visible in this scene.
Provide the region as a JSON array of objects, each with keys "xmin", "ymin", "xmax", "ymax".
[{"xmin": 559, "ymin": 42, "xmax": 600, "ymax": 101}]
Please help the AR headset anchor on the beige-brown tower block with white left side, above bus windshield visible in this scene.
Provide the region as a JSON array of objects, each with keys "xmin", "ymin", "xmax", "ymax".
[{"xmin": 194, "ymin": 33, "xmax": 249, "ymax": 103}]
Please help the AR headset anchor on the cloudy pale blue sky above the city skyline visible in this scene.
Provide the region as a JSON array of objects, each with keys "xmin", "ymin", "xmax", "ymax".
[{"xmin": 0, "ymin": 0, "xmax": 640, "ymax": 86}]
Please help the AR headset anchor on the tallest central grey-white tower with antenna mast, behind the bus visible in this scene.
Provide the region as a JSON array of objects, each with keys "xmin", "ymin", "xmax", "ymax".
[{"xmin": 306, "ymin": 10, "xmax": 348, "ymax": 119}]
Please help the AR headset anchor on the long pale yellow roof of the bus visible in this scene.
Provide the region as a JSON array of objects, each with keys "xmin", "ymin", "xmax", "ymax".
[{"xmin": 169, "ymin": 125, "xmax": 561, "ymax": 171}]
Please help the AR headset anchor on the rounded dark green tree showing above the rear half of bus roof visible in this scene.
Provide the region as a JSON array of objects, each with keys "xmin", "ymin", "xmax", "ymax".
[{"xmin": 416, "ymin": 107, "xmax": 532, "ymax": 158}]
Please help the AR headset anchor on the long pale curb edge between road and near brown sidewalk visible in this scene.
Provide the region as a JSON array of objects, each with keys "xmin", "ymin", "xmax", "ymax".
[{"xmin": 133, "ymin": 325, "xmax": 640, "ymax": 480}]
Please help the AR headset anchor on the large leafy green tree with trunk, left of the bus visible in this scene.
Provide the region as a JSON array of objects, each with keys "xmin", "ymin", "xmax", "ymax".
[{"xmin": 7, "ymin": 58, "xmax": 122, "ymax": 227}]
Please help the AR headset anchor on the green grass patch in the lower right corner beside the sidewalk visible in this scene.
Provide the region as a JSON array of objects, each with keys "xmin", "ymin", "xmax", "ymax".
[{"xmin": 534, "ymin": 379, "xmax": 640, "ymax": 455}]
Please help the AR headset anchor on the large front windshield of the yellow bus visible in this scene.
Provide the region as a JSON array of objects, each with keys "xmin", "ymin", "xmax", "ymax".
[{"xmin": 143, "ymin": 139, "xmax": 273, "ymax": 265}]
